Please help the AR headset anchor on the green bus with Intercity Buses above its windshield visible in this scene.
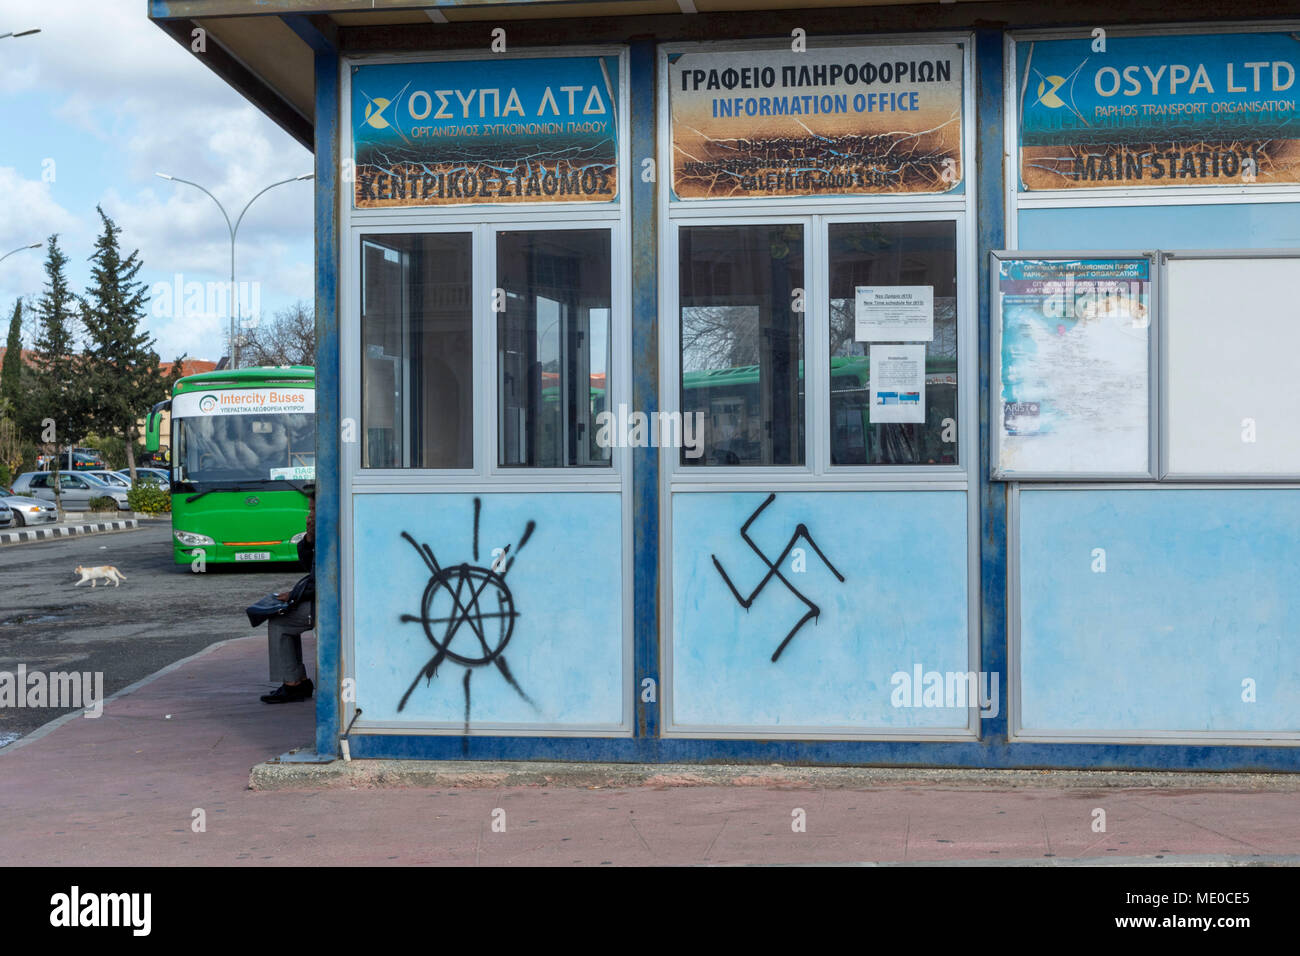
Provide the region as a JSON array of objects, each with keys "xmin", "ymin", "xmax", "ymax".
[{"xmin": 146, "ymin": 365, "xmax": 316, "ymax": 564}]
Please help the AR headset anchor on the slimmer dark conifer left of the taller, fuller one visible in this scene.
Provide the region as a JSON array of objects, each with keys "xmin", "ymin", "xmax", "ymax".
[{"xmin": 23, "ymin": 235, "xmax": 90, "ymax": 506}]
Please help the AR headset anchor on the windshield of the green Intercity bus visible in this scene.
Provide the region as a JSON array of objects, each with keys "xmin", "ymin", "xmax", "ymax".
[{"xmin": 172, "ymin": 414, "xmax": 316, "ymax": 485}]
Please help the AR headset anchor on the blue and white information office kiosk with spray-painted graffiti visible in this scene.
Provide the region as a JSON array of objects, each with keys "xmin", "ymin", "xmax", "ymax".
[{"xmin": 153, "ymin": 0, "xmax": 1300, "ymax": 770}]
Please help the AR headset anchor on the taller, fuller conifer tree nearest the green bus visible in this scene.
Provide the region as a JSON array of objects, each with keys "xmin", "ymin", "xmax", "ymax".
[{"xmin": 78, "ymin": 207, "xmax": 181, "ymax": 483}]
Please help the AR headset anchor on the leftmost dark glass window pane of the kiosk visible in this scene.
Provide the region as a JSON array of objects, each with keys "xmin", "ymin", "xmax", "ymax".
[{"xmin": 361, "ymin": 233, "xmax": 475, "ymax": 468}]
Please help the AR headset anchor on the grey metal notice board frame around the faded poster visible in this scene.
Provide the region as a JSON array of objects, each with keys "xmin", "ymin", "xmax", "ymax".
[{"xmin": 988, "ymin": 250, "xmax": 1162, "ymax": 481}]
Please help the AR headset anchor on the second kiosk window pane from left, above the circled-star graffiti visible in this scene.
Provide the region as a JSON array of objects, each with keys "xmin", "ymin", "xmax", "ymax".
[{"xmin": 495, "ymin": 229, "xmax": 612, "ymax": 468}]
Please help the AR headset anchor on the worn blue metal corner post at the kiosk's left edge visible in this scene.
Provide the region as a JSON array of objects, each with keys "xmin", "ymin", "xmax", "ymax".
[{"xmin": 316, "ymin": 53, "xmax": 343, "ymax": 754}]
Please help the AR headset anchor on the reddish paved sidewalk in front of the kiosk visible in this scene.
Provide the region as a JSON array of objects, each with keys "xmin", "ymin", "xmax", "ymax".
[{"xmin": 0, "ymin": 636, "xmax": 1300, "ymax": 865}]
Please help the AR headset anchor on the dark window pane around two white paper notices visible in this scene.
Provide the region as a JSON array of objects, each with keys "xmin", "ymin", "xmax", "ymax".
[{"xmin": 828, "ymin": 221, "xmax": 958, "ymax": 464}]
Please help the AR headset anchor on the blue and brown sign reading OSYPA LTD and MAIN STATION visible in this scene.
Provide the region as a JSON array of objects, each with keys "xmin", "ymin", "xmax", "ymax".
[{"xmin": 1017, "ymin": 33, "xmax": 1300, "ymax": 190}]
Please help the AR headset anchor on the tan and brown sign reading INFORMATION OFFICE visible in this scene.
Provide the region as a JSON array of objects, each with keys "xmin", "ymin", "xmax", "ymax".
[{"xmin": 668, "ymin": 43, "xmax": 963, "ymax": 199}]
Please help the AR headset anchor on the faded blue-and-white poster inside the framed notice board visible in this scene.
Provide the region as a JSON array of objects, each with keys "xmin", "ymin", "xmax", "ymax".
[{"xmin": 993, "ymin": 258, "xmax": 1151, "ymax": 477}]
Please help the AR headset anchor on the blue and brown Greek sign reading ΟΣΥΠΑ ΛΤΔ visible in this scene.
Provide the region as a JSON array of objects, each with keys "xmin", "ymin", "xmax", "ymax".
[{"xmin": 351, "ymin": 56, "xmax": 619, "ymax": 209}]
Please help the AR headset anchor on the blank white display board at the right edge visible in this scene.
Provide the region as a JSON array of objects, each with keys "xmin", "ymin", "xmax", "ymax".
[{"xmin": 1162, "ymin": 252, "xmax": 1300, "ymax": 477}]
